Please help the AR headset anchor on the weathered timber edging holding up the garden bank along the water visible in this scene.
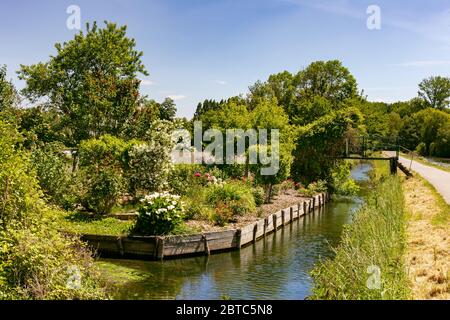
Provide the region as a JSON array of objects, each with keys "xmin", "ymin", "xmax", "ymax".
[{"xmin": 81, "ymin": 193, "xmax": 330, "ymax": 260}]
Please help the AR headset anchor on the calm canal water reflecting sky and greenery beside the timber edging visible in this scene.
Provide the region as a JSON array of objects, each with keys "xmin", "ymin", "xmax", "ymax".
[{"xmin": 98, "ymin": 164, "xmax": 370, "ymax": 299}]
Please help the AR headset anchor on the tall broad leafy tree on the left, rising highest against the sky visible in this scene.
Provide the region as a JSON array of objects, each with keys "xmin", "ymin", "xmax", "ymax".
[{"xmin": 18, "ymin": 22, "xmax": 148, "ymax": 146}]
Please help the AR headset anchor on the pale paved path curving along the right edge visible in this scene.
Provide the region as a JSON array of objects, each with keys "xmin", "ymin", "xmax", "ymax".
[{"xmin": 399, "ymin": 156, "xmax": 450, "ymax": 204}]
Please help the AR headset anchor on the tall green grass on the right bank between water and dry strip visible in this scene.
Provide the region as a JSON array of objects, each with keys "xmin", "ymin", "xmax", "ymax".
[{"xmin": 311, "ymin": 176, "xmax": 409, "ymax": 300}]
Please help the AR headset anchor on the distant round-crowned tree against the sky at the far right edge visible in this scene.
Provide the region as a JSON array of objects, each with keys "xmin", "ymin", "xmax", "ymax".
[{"xmin": 419, "ymin": 76, "xmax": 450, "ymax": 110}]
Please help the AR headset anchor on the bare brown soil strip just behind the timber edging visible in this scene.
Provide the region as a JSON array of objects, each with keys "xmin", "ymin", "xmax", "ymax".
[{"xmin": 186, "ymin": 190, "xmax": 308, "ymax": 232}]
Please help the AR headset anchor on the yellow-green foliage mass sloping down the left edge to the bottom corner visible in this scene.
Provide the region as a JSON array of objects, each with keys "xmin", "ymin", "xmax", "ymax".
[{"xmin": 0, "ymin": 121, "xmax": 106, "ymax": 299}]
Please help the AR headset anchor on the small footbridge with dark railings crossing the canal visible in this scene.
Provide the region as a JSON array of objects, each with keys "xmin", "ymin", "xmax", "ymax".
[{"xmin": 335, "ymin": 135, "xmax": 411, "ymax": 176}]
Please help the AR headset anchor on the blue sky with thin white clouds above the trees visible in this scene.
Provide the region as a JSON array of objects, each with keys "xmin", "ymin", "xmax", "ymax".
[{"xmin": 0, "ymin": 0, "xmax": 450, "ymax": 117}]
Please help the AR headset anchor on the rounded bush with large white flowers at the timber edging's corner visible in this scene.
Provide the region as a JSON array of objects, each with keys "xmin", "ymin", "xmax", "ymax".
[{"xmin": 133, "ymin": 193, "xmax": 184, "ymax": 235}]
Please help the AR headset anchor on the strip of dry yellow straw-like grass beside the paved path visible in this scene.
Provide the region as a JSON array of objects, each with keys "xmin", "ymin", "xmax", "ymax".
[{"xmin": 404, "ymin": 178, "xmax": 450, "ymax": 300}]
